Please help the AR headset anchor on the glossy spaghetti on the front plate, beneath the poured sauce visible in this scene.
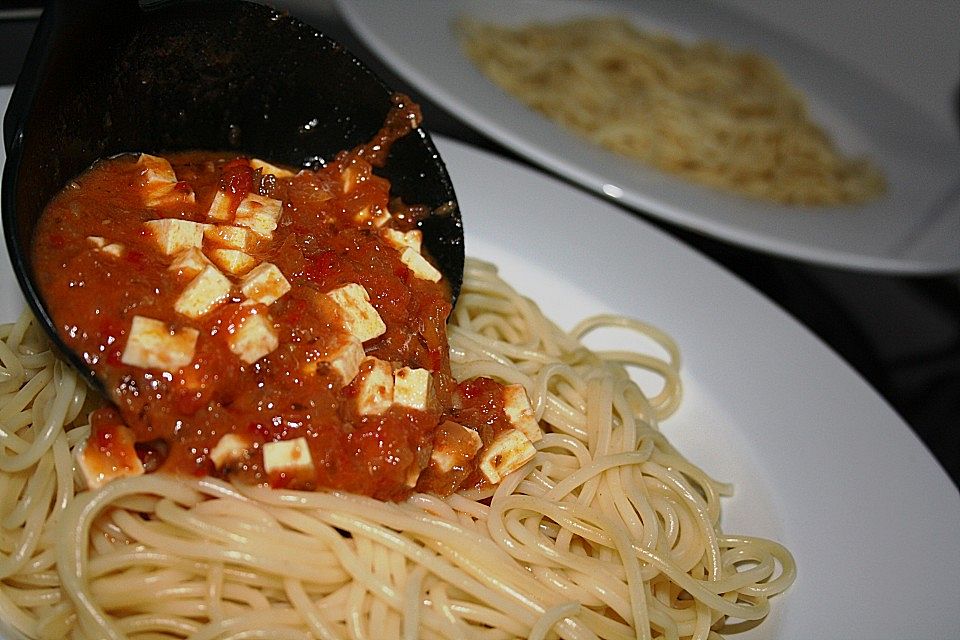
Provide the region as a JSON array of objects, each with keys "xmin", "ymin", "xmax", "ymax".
[{"xmin": 0, "ymin": 261, "xmax": 795, "ymax": 640}]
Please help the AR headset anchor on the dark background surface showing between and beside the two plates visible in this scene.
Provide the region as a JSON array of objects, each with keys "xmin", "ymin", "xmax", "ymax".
[{"xmin": 0, "ymin": 0, "xmax": 960, "ymax": 485}]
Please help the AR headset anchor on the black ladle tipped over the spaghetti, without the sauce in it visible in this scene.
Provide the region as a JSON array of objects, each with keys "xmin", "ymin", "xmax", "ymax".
[{"xmin": 2, "ymin": 0, "xmax": 464, "ymax": 386}]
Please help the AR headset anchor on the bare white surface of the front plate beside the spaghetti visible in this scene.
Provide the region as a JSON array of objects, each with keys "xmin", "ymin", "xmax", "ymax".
[{"xmin": 0, "ymin": 86, "xmax": 960, "ymax": 640}]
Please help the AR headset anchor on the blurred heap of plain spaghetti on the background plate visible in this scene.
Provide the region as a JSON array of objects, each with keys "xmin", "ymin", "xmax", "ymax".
[{"xmin": 457, "ymin": 18, "xmax": 885, "ymax": 205}]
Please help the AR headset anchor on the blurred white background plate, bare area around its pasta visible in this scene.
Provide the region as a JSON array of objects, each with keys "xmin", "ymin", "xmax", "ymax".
[{"xmin": 339, "ymin": 0, "xmax": 960, "ymax": 273}]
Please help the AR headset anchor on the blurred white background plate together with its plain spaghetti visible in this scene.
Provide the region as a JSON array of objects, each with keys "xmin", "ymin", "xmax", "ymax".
[{"xmin": 339, "ymin": 0, "xmax": 960, "ymax": 274}]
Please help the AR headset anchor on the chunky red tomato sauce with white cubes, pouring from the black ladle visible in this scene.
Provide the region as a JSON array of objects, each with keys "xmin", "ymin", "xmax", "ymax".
[{"xmin": 33, "ymin": 100, "xmax": 539, "ymax": 500}]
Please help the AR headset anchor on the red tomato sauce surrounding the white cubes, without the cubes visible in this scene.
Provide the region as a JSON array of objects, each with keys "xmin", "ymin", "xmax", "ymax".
[{"xmin": 33, "ymin": 103, "xmax": 528, "ymax": 500}]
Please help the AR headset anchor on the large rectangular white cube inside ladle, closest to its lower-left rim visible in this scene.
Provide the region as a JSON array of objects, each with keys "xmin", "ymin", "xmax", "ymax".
[{"xmin": 120, "ymin": 316, "xmax": 200, "ymax": 372}]
